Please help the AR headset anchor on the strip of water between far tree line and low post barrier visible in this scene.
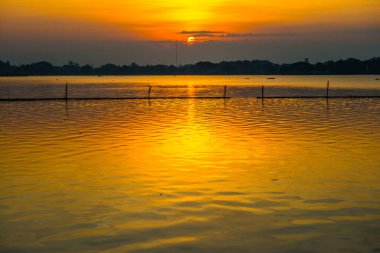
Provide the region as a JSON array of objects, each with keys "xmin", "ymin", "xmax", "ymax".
[{"xmin": 0, "ymin": 75, "xmax": 380, "ymax": 99}]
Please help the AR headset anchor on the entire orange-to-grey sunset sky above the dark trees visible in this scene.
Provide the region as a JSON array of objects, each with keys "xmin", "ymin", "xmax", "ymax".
[{"xmin": 0, "ymin": 0, "xmax": 380, "ymax": 66}]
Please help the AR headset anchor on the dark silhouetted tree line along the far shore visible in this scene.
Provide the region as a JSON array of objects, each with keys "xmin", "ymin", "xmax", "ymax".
[{"xmin": 0, "ymin": 57, "xmax": 380, "ymax": 76}]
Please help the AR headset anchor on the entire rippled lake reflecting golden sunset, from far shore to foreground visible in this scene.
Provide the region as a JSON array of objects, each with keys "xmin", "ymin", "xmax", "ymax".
[{"xmin": 0, "ymin": 76, "xmax": 380, "ymax": 253}]
